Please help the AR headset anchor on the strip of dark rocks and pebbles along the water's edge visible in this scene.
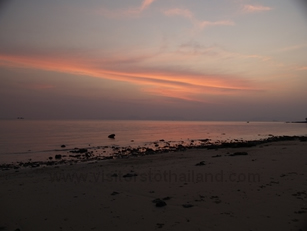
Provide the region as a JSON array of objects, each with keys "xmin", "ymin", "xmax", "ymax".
[{"xmin": 0, "ymin": 135, "xmax": 307, "ymax": 171}]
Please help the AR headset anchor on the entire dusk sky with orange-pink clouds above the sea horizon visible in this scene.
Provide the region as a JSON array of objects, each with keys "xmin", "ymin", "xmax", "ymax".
[{"xmin": 0, "ymin": 0, "xmax": 307, "ymax": 121}]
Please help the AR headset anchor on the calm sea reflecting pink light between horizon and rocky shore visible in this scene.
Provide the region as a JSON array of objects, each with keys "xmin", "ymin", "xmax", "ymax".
[{"xmin": 0, "ymin": 119, "xmax": 307, "ymax": 163}]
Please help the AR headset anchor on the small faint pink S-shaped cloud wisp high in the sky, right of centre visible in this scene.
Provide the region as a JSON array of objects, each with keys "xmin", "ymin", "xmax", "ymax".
[{"xmin": 163, "ymin": 8, "xmax": 235, "ymax": 29}]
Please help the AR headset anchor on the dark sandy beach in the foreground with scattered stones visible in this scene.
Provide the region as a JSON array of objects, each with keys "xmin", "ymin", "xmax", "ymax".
[{"xmin": 0, "ymin": 140, "xmax": 307, "ymax": 231}]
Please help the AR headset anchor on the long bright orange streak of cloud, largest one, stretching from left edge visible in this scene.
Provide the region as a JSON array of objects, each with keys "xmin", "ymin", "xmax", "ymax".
[{"xmin": 0, "ymin": 51, "xmax": 259, "ymax": 101}]
